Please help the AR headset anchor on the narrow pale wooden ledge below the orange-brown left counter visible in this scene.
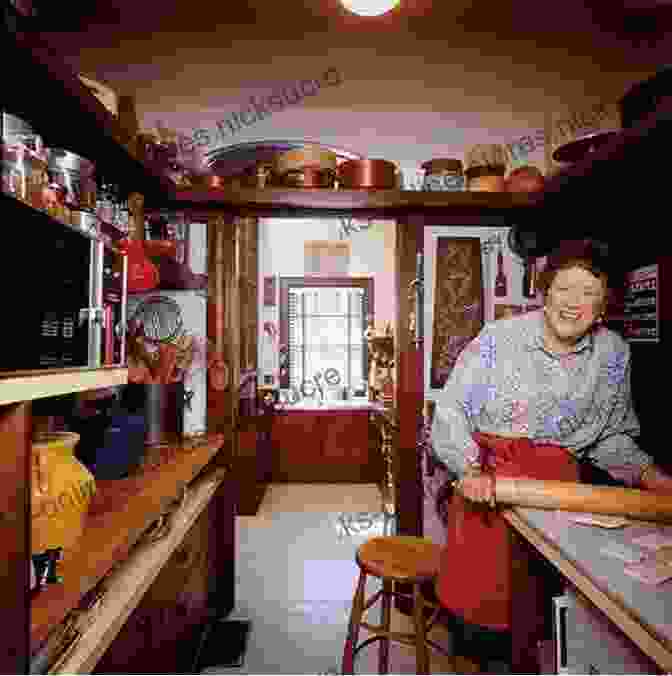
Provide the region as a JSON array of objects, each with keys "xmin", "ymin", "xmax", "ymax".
[{"xmin": 53, "ymin": 471, "xmax": 224, "ymax": 674}]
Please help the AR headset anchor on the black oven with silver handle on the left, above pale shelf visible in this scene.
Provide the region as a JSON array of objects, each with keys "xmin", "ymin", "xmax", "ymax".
[{"xmin": 0, "ymin": 209, "xmax": 126, "ymax": 372}]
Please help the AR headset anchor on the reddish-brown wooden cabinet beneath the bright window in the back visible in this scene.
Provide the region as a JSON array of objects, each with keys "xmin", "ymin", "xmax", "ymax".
[{"xmin": 271, "ymin": 410, "xmax": 382, "ymax": 483}]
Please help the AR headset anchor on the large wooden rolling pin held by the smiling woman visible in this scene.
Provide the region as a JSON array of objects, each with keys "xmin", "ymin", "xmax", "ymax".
[{"xmin": 476, "ymin": 477, "xmax": 672, "ymax": 523}]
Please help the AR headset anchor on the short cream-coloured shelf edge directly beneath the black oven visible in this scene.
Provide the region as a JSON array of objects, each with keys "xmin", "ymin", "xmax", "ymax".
[{"xmin": 0, "ymin": 366, "xmax": 128, "ymax": 405}]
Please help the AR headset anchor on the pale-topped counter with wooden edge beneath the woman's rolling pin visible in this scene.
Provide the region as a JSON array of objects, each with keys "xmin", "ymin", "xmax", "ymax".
[{"xmin": 504, "ymin": 508, "xmax": 672, "ymax": 673}]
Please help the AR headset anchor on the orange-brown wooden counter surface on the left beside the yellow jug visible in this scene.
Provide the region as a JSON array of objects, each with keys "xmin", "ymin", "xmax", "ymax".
[{"xmin": 30, "ymin": 434, "xmax": 224, "ymax": 648}]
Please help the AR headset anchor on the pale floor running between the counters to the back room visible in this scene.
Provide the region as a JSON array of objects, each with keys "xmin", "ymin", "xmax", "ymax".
[{"xmin": 204, "ymin": 484, "xmax": 476, "ymax": 674}]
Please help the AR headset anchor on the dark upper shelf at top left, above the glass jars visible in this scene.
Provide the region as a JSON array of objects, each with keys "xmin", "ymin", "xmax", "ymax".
[{"xmin": 0, "ymin": 3, "xmax": 175, "ymax": 200}]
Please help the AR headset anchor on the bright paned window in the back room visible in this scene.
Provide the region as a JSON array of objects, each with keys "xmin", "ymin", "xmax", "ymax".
[{"xmin": 280, "ymin": 277, "xmax": 373, "ymax": 396}]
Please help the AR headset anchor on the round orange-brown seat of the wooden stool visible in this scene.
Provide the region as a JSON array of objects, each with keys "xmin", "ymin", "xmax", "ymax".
[{"xmin": 357, "ymin": 535, "xmax": 441, "ymax": 584}]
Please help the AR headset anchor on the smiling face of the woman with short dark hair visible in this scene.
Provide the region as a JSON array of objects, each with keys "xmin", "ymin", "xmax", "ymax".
[{"xmin": 544, "ymin": 267, "xmax": 606, "ymax": 349}]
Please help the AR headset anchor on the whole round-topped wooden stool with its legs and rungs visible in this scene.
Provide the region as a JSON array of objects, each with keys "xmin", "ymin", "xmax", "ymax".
[{"xmin": 342, "ymin": 536, "xmax": 448, "ymax": 674}]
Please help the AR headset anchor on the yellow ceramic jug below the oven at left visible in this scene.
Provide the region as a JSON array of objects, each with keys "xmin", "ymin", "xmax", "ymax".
[{"xmin": 31, "ymin": 432, "xmax": 96, "ymax": 558}]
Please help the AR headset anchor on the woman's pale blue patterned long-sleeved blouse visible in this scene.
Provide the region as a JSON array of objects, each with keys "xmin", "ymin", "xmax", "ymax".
[{"xmin": 432, "ymin": 310, "xmax": 653, "ymax": 485}]
